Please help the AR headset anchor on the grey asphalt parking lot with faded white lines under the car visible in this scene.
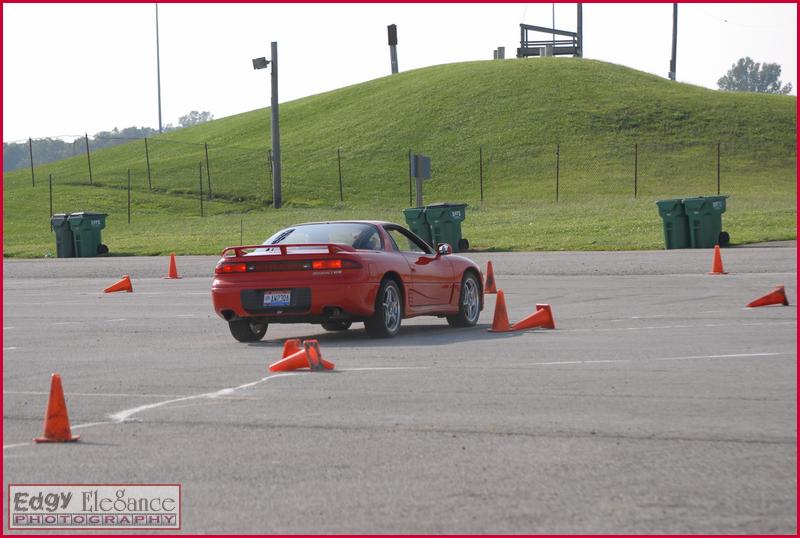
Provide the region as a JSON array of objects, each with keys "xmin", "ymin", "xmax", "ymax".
[{"xmin": 3, "ymin": 242, "xmax": 797, "ymax": 534}]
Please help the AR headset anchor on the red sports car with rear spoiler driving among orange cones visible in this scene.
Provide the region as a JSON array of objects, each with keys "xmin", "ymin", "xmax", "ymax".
[{"xmin": 211, "ymin": 221, "xmax": 483, "ymax": 342}]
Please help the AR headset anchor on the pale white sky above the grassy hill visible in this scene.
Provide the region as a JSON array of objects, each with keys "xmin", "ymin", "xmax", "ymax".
[{"xmin": 3, "ymin": 3, "xmax": 797, "ymax": 142}]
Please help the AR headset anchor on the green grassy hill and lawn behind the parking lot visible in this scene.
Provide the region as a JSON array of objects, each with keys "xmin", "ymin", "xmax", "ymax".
[{"xmin": 3, "ymin": 58, "xmax": 797, "ymax": 256}]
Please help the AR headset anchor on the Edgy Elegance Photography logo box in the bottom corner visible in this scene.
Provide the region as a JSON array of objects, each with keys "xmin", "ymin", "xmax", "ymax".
[{"xmin": 8, "ymin": 484, "xmax": 181, "ymax": 530}]
